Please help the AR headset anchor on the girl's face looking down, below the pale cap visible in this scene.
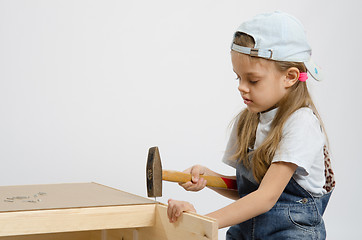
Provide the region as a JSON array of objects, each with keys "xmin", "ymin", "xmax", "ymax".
[{"xmin": 231, "ymin": 51, "xmax": 288, "ymax": 113}]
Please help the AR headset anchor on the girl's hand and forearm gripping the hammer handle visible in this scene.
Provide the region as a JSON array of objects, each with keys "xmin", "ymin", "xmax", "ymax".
[{"xmin": 180, "ymin": 165, "xmax": 239, "ymax": 200}]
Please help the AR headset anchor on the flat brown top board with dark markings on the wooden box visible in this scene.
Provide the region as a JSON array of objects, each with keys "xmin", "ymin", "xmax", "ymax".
[{"xmin": 0, "ymin": 183, "xmax": 155, "ymax": 212}]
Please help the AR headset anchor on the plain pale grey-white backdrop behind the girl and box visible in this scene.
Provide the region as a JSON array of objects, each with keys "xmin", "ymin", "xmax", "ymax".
[{"xmin": 0, "ymin": 0, "xmax": 362, "ymax": 240}]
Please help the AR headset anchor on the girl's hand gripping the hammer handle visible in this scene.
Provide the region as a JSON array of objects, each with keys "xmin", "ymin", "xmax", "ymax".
[{"xmin": 179, "ymin": 165, "xmax": 207, "ymax": 192}]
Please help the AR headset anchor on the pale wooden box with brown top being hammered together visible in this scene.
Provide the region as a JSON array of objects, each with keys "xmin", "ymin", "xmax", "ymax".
[{"xmin": 0, "ymin": 183, "xmax": 218, "ymax": 240}]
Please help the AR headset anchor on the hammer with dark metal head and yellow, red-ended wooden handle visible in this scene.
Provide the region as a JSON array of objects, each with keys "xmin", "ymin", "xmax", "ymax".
[{"xmin": 146, "ymin": 147, "xmax": 237, "ymax": 197}]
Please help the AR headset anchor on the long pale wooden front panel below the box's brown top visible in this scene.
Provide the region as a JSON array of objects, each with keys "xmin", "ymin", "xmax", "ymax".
[{"xmin": 0, "ymin": 204, "xmax": 156, "ymax": 236}]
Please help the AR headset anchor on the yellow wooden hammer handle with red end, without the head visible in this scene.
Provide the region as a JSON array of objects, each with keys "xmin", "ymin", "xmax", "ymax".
[{"xmin": 162, "ymin": 170, "xmax": 237, "ymax": 190}]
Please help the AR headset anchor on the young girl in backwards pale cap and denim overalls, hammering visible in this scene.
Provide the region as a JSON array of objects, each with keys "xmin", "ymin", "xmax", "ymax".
[{"xmin": 168, "ymin": 12, "xmax": 335, "ymax": 240}]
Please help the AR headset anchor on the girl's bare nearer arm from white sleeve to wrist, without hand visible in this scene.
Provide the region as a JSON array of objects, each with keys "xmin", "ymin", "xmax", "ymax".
[{"xmin": 207, "ymin": 162, "xmax": 297, "ymax": 228}]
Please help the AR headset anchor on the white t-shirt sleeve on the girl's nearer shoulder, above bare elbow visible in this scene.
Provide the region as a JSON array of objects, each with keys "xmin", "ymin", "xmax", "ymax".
[{"xmin": 272, "ymin": 108, "xmax": 325, "ymax": 176}]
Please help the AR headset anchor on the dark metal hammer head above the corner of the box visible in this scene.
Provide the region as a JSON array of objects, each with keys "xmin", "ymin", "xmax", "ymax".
[{"xmin": 146, "ymin": 147, "xmax": 162, "ymax": 197}]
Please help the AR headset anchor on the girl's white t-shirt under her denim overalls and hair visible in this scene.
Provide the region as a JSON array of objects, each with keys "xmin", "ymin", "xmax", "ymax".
[{"xmin": 223, "ymin": 107, "xmax": 326, "ymax": 197}]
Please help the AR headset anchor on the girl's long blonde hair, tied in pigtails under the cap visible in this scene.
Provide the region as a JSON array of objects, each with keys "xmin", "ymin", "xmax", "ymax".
[{"xmin": 232, "ymin": 32, "xmax": 325, "ymax": 183}]
